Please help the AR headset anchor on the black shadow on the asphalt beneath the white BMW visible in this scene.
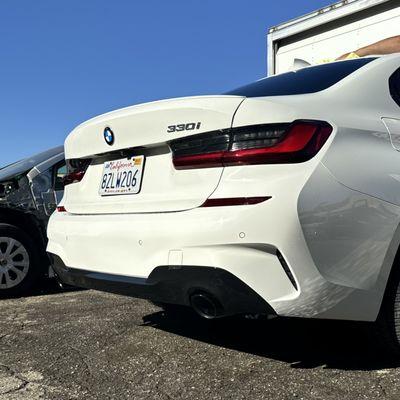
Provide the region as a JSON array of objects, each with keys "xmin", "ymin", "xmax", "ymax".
[{"xmin": 143, "ymin": 312, "xmax": 400, "ymax": 371}]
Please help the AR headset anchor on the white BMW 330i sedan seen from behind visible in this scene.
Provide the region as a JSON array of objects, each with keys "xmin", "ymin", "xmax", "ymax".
[{"xmin": 48, "ymin": 55, "xmax": 400, "ymax": 349}]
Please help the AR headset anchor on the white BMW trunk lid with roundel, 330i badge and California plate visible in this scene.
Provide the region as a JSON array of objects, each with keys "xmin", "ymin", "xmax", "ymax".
[{"xmin": 63, "ymin": 96, "xmax": 243, "ymax": 214}]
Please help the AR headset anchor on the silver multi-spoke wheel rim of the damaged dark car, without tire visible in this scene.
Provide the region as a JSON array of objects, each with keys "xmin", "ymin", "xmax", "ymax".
[{"xmin": 0, "ymin": 237, "xmax": 29, "ymax": 289}]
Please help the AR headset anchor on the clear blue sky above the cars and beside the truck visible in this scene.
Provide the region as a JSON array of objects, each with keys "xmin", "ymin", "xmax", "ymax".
[{"xmin": 0, "ymin": 0, "xmax": 332, "ymax": 165}]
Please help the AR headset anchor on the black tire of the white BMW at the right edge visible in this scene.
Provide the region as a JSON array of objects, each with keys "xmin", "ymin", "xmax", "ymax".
[{"xmin": 375, "ymin": 270, "xmax": 400, "ymax": 359}]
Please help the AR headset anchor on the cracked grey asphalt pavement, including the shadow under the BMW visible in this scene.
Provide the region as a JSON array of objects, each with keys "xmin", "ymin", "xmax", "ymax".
[{"xmin": 0, "ymin": 287, "xmax": 400, "ymax": 400}]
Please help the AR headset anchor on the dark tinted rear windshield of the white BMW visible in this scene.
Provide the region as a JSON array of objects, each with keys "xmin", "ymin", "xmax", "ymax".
[{"xmin": 225, "ymin": 57, "xmax": 376, "ymax": 97}]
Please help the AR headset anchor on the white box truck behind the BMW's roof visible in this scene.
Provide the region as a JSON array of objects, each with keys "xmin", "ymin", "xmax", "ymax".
[{"xmin": 267, "ymin": 0, "xmax": 400, "ymax": 75}]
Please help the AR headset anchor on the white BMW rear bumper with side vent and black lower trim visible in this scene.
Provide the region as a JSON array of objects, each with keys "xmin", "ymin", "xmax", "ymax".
[{"xmin": 47, "ymin": 180, "xmax": 380, "ymax": 321}]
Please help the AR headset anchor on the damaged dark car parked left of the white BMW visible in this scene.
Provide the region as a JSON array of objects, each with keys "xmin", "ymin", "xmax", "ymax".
[{"xmin": 0, "ymin": 146, "xmax": 66, "ymax": 297}]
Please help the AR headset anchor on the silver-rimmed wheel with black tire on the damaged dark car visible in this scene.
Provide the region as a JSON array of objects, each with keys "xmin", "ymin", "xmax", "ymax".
[{"xmin": 0, "ymin": 224, "xmax": 40, "ymax": 297}]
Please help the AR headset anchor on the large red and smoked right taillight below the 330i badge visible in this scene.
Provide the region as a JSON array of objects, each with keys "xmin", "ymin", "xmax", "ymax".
[{"xmin": 169, "ymin": 121, "xmax": 332, "ymax": 169}]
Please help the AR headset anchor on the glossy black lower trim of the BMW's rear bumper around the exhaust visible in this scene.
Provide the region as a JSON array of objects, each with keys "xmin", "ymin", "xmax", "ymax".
[{"xmin": 50, "ymin": 254, "xmax": 275, "ymax": 317}]
